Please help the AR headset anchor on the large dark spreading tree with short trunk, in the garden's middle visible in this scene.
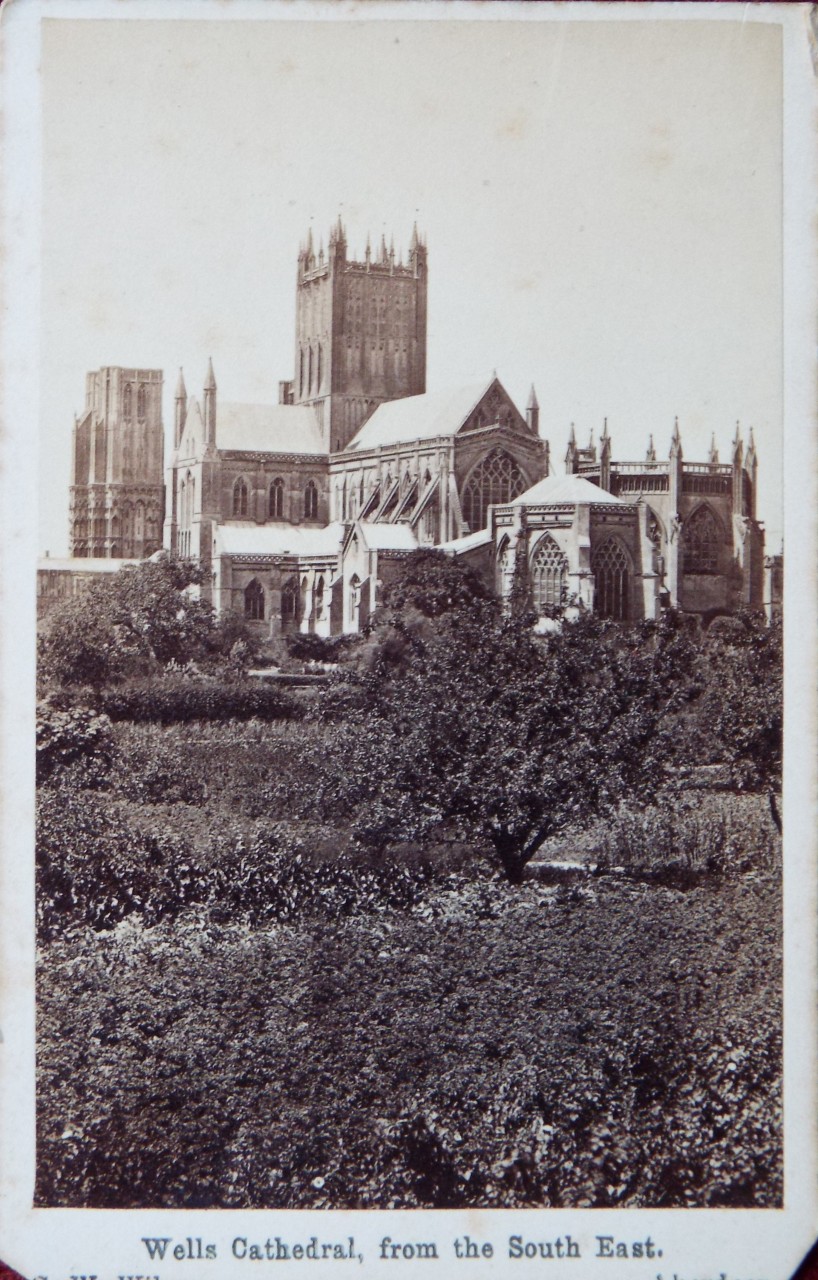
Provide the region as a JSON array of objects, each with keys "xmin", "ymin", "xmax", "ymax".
[{"xmin": 320, "ymin": 600, "xmax": 695, "ymax": 882}]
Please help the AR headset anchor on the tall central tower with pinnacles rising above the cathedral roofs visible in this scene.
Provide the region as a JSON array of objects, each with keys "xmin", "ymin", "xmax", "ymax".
[{"xmin": 282, "ymin": 218, "xmax": 426, "ymax": 453}]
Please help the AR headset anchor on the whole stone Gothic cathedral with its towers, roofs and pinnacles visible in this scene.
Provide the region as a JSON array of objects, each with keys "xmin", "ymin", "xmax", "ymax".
[{"xmin": 56, "ymin": 219, "xmax": 781, "ymax": 639}]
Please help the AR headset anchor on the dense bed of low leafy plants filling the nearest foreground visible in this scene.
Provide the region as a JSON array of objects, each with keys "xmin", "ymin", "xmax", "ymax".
[{"xmin": 37, "ymin": 877, "xmax": 781, "ymax": 1208}]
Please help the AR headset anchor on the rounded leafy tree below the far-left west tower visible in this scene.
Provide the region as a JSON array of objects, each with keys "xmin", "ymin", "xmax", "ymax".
[{"xmin": 38, "ymin": 556, "xmax": 215, "ymax": 687}]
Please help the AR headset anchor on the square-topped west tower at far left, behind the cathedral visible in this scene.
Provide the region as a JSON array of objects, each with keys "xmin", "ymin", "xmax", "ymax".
[{"xmin": 69, "ymin": 366, "xmax": 165, "ymax": 558}]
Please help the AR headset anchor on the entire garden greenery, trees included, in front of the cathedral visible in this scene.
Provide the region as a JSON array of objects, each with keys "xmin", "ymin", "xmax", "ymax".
[{"xmin": 36, "ymin": 552, "xmax": 782, "ymax": 1208}]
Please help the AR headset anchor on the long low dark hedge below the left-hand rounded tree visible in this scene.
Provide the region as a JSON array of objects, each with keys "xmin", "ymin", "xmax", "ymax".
[{"xmin": 99, "ymin": 676, "xmax": 302, "ymax": 724}]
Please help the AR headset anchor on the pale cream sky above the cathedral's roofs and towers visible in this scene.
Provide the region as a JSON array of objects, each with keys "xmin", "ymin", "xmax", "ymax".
[{"xmin": 40, "ymin": 15, "xmax": 782, "ymax": 556}]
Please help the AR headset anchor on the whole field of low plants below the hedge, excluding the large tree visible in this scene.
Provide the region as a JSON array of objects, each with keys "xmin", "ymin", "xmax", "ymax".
[{"xmin": 37, "ymin": 722, "xmax": 781, "ymax": 1207}]
